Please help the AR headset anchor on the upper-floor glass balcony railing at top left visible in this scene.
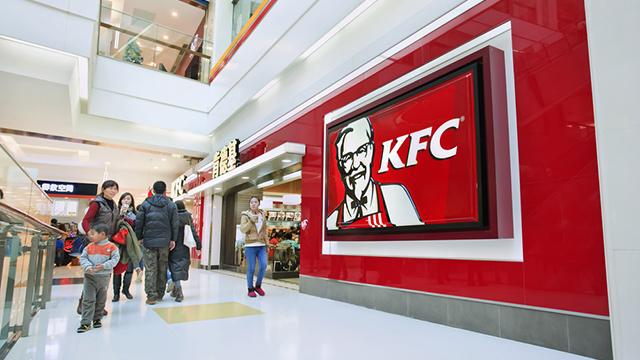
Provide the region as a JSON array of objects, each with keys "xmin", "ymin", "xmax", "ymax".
[{"xmin": 98, "ymin": 6, "xmax": 213, "ymax": 82}]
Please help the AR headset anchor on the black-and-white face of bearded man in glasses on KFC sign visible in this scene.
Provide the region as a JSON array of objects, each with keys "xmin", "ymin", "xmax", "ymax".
[{"xmin": 335, "ymin": 117, "xmax": 374, "ymax": 200}]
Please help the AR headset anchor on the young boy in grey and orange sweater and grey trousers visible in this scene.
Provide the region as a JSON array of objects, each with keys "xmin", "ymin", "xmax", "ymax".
[{"xmin": 78, "ymin": 224, "xmax": 120, "ymax": 333}]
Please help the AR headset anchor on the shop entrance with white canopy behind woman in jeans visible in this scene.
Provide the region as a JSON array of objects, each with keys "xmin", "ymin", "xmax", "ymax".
[{"xmin": 184, "ymin": 143, "xmax": 305, "ymax": 279}]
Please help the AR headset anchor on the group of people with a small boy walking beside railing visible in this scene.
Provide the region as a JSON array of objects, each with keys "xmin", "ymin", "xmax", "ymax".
[{"xmin": 78, "ymin": 180, "xmax": 202, "ymax": 333}]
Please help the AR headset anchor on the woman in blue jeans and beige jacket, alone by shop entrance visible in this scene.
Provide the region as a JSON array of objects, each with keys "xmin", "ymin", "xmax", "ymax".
[{"xmin": 240, "ymin": 196, "xmax": 268, "ymax": 297}]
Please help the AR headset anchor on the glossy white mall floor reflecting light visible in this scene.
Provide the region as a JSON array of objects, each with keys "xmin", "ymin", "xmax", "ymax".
[{"xmin": 7, "ymin": 270, "xmax": 596, "ymax": 360}]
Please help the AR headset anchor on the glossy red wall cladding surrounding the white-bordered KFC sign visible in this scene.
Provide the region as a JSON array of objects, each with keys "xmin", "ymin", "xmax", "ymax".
[{"xmin": 241, "ymin": 0, "xmax": 608, "ymax": 316}]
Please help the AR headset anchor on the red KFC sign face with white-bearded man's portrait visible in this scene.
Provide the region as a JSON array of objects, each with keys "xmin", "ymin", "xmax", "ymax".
[{"xmin": 325, "ymin": 63, "xmax": 486, "ymax": 235}]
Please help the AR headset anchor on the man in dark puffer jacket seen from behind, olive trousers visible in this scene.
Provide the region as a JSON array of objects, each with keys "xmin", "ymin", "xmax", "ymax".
[{"xmin": 135, "ymin": 181, "xmax": 179, "ymax": 305}]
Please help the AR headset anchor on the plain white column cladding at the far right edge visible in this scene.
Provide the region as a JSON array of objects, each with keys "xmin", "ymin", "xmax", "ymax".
[{"xmin": 585, "ymin": 0, "xmax": 640, "ymax": 359}]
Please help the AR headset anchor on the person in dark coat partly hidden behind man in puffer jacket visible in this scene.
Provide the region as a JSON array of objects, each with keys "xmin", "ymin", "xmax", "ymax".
[{"xmin": 169, "ymin": 200, "xmax": 202, "ymax": 302}]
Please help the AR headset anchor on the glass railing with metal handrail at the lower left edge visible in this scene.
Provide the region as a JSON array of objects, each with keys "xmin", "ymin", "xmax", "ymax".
[{"xmin": 0, "ymin": 144, "xmax": 64, "ymax": 356}]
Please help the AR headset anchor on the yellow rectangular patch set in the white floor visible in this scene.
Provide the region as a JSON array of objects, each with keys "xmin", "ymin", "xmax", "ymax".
[{"xmin": 153, "ymin": 301, "xmax": 264, "ymax": 324}]
